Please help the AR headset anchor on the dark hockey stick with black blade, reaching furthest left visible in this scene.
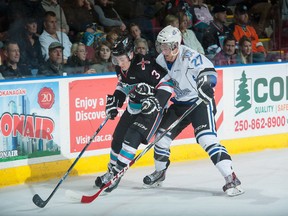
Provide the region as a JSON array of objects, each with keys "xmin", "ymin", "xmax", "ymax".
[{"xmin": 32, "ymin": 116, "xmax": 109, "ymax": 208}]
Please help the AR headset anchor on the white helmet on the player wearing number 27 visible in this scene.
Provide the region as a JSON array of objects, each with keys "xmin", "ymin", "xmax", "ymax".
[{"xmin": 156, "ymin": 25, "xmax": 182, "ymax": 53}]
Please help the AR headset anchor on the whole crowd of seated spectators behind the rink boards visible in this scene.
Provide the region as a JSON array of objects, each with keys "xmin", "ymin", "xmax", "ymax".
[{"xmin": 0, "ymin": 0, "xmax": 288, "ymax": 79}]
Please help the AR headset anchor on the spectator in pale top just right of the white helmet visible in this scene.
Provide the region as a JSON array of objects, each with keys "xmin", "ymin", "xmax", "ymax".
[{"xmin": 178, "ymin": 11, "xmax": 205, "ymax": 54}]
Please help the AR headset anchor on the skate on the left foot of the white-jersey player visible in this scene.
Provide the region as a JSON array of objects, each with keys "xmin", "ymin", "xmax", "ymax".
[{"xmin": 143, "ymin": 161, "xmax": 170, "ymax": 188}]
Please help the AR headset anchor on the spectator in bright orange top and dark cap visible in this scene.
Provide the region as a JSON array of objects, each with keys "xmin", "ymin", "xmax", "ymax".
[{"xmin": 232, "ymin": 4, "xmax": 266, "ymax": 62}]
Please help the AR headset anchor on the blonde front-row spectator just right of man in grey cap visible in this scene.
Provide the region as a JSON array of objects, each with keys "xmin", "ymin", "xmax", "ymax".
[{"xmin": 64, "ymin": 42, "xmax": 96, "ymax": 75}]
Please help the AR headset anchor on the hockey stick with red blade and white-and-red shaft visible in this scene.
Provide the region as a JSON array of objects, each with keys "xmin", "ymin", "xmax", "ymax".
[{"xmin": 81, "ymin": 98, "xmax": 203, "ymax": 203}]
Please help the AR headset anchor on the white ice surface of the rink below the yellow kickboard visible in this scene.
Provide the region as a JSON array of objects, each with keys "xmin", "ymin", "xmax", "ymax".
[{"xmin": 0, "ymin": 149, "xmax": 288, "ymax": 216}]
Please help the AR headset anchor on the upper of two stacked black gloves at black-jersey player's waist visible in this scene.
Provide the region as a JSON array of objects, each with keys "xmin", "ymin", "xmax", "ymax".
[{"xmin": 129, "ymin": 83, "xmax": 154, "ymax": 103}]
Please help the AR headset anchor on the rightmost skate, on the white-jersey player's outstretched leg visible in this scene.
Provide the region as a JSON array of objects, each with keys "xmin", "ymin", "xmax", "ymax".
[{"xmin": 223, "ymin": 172, "xmax": 245, "ymax": 196}]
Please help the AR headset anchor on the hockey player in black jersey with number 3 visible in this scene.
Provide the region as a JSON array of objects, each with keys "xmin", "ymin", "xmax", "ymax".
[{"xmin": 95, "ymin": 37, "xmax": 173, "ymax": 192}]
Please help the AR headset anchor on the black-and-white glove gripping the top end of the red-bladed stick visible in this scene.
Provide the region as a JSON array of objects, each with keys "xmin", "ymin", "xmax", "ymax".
[{"xmin": 197, "ymin": 76, "xmax": 214, "ymax": 102}]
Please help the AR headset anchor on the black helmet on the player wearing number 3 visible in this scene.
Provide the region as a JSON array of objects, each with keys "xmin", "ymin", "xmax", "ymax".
[{"xmin": 111, "ymin": 37, "xmax": 134, "ymax": 56}]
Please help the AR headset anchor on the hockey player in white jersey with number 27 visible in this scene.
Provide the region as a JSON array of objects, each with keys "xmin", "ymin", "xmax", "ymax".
[{"xmin": 143, "ymin": 25, "xmax": 244, "ymax": 196}]
